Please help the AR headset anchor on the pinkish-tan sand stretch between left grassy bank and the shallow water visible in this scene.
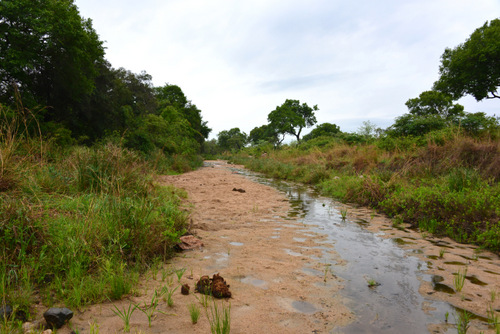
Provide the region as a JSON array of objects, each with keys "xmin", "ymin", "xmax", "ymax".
[{"xmin": 64, "ymin": 162, "xmax": 353, "ymax": 334}]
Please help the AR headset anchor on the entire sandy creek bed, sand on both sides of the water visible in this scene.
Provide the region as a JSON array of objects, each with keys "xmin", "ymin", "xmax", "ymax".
[{"xmin": 53, "ymin": 161, "xmax": 500, "ymax": 334}]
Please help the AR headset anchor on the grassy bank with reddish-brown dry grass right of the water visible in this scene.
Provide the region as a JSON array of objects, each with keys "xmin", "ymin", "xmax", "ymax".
[{"xmin": 233, "ymin": 131, "xmax": 500, "ymax": 252}]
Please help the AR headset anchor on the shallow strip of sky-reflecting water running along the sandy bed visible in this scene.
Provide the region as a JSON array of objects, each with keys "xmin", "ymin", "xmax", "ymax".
[{"xmin": 234, "ymin": 170, "xmax": 455, "ymax": 333}]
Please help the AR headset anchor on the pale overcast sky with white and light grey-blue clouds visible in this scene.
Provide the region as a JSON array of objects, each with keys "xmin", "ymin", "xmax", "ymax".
[{"xmin": 75, "ymin": 0, "xmax": 500, "ymax": 138}]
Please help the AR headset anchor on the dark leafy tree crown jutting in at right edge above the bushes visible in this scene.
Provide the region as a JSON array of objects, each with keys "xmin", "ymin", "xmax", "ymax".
[{"xmin": 434, "ymin": 19, "xmax": 500, "ymax": 101}]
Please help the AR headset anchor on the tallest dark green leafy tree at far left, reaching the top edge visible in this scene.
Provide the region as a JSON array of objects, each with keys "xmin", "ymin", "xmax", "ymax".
[{"xmin": 0, "ymin": 0, "xmax": 104, "ymax": 128}]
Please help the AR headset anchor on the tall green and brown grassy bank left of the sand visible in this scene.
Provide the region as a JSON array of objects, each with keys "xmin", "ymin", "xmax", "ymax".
[{"xmin": 0, "ymin": 111, "xmax": 190, "ymax": 324}]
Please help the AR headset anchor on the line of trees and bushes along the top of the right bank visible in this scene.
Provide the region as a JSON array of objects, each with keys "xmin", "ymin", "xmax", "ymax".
[{"xmin": 214, "ymin": 19, "xmax": 500, "ymax": 151}]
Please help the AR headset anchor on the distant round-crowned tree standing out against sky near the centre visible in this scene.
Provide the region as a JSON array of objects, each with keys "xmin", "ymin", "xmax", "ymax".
[{"xmin": 267, "ymin": 100, "xmax": 318, "ymax": 144}]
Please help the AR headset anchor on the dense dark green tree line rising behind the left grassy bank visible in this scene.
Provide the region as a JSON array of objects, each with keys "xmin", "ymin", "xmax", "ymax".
[{"xmin": 0, "ymin": 0, "xmax": 211, "ymax": 154}]
